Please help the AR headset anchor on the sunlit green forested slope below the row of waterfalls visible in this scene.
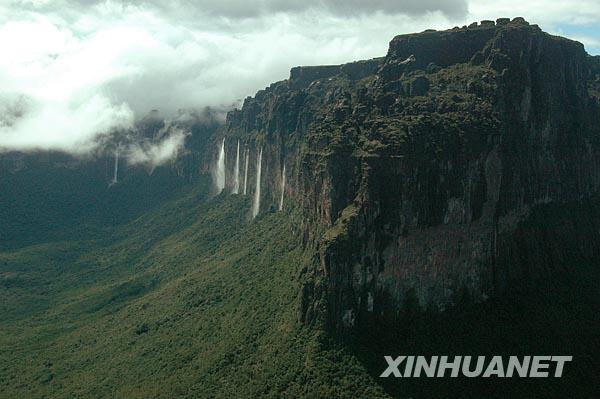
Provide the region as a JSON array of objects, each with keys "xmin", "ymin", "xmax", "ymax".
[{"xmin": 0, "ymin": 179, "xmax": 384, "ymax": 398}]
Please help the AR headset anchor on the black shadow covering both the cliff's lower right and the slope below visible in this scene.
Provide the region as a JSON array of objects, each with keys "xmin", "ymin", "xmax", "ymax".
[{"xmin": 340, "ymin": 200, "xmax": 600, "ymax": 399}]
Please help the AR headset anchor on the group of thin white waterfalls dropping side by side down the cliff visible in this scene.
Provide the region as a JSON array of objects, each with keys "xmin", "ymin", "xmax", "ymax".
[{"xmin": 213, "ymin": 139, "xmax": 285, "ymax": 218}]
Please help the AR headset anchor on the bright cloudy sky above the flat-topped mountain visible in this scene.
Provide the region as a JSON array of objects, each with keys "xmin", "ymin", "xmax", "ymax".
[{"xmin": 0, "ymin": 0, "xmax": 600, "ymax": 153}]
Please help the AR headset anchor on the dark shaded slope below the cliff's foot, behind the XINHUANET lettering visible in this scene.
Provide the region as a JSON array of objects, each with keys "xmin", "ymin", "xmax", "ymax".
[{"xmin": 349, "ymin": 276, "xmax": 600, "ymax": 399}]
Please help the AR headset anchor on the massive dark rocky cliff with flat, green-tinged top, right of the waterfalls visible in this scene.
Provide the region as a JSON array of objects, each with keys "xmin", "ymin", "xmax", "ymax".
[{"xmin": 215, "ymin": 18, "xmax": 600, "ymax": 330}]
